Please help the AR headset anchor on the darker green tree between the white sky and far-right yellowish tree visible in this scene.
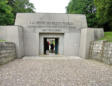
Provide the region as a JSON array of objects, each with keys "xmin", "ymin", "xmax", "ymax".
[{"xmin": 67, "ymin": 0, "xmax": 97, "ymax": 27}]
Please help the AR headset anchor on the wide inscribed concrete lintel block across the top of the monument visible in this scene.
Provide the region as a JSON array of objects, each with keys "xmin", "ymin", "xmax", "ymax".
[{"xmin": 15, "ymin": 13, "xmax": 87, "ymax": 29}]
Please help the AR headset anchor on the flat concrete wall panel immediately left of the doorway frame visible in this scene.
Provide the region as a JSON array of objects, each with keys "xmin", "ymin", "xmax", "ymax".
[{"xmin": 24, "ymin": 28, "xmax": 39, "ymax": 56}]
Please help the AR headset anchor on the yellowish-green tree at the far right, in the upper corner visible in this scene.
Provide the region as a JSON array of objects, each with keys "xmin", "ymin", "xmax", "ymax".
[{"xmin": 94, "ymin": 0, "xmax": 112, "ymax": 31}]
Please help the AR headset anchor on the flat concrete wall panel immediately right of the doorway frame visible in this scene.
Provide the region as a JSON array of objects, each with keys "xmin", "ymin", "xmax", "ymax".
[{"xmin": 64, "ymin": 31, "xmax": 80, "ymax": 56}]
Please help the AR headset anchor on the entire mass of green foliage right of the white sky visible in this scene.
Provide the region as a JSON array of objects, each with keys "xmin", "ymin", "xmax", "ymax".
[{"xmin": 67, "ymin": 0, "xmax": 112, "ymax": 31}]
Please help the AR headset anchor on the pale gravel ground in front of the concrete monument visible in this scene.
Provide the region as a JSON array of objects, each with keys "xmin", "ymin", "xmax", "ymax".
[{"xmin": 0, "ymin": 58, "xmax": 112, "ymax": 86}]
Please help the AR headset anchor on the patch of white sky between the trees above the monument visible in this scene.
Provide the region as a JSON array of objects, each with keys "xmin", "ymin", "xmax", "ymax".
[{"xmin": 30, "ymin": 0, "xmax": 70, "ymax": 13}]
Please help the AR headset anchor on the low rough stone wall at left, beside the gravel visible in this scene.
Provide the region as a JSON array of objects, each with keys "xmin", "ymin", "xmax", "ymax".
[{"xmin": 0, "ymin": 42, "xmax": 16, "ymax": 64}]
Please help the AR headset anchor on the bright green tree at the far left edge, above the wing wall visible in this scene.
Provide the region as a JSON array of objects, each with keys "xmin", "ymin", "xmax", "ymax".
[{"xmin": 0, "ymin": 0, "xmax": 14, "ymax": 25}]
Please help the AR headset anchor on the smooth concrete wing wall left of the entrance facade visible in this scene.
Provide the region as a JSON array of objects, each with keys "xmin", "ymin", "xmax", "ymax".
[{"xmin": 0, "ymin": 26, "xmax": 24, "ymax": 58}]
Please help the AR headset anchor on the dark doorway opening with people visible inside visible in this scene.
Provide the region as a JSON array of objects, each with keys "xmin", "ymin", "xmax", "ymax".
[{"xmin": 44, "ymin": 38, "xmax": 59, "ymax": 55}]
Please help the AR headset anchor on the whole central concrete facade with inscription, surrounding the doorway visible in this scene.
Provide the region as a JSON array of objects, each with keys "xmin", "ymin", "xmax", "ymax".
[{"xmin": 19, "ymin": 13, "xmax": 84, "ymax": 56}]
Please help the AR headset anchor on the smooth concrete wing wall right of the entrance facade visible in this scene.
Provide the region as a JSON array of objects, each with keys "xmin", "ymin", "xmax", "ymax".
[{"xmin": 79, "ymin": 28, "xmax": 104, "ymax": 58}]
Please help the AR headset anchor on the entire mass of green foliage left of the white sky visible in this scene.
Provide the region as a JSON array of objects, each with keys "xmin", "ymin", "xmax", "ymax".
[{"xmin": 0, "ymin": 0, "xmax": 35, "ymax": 25}]
